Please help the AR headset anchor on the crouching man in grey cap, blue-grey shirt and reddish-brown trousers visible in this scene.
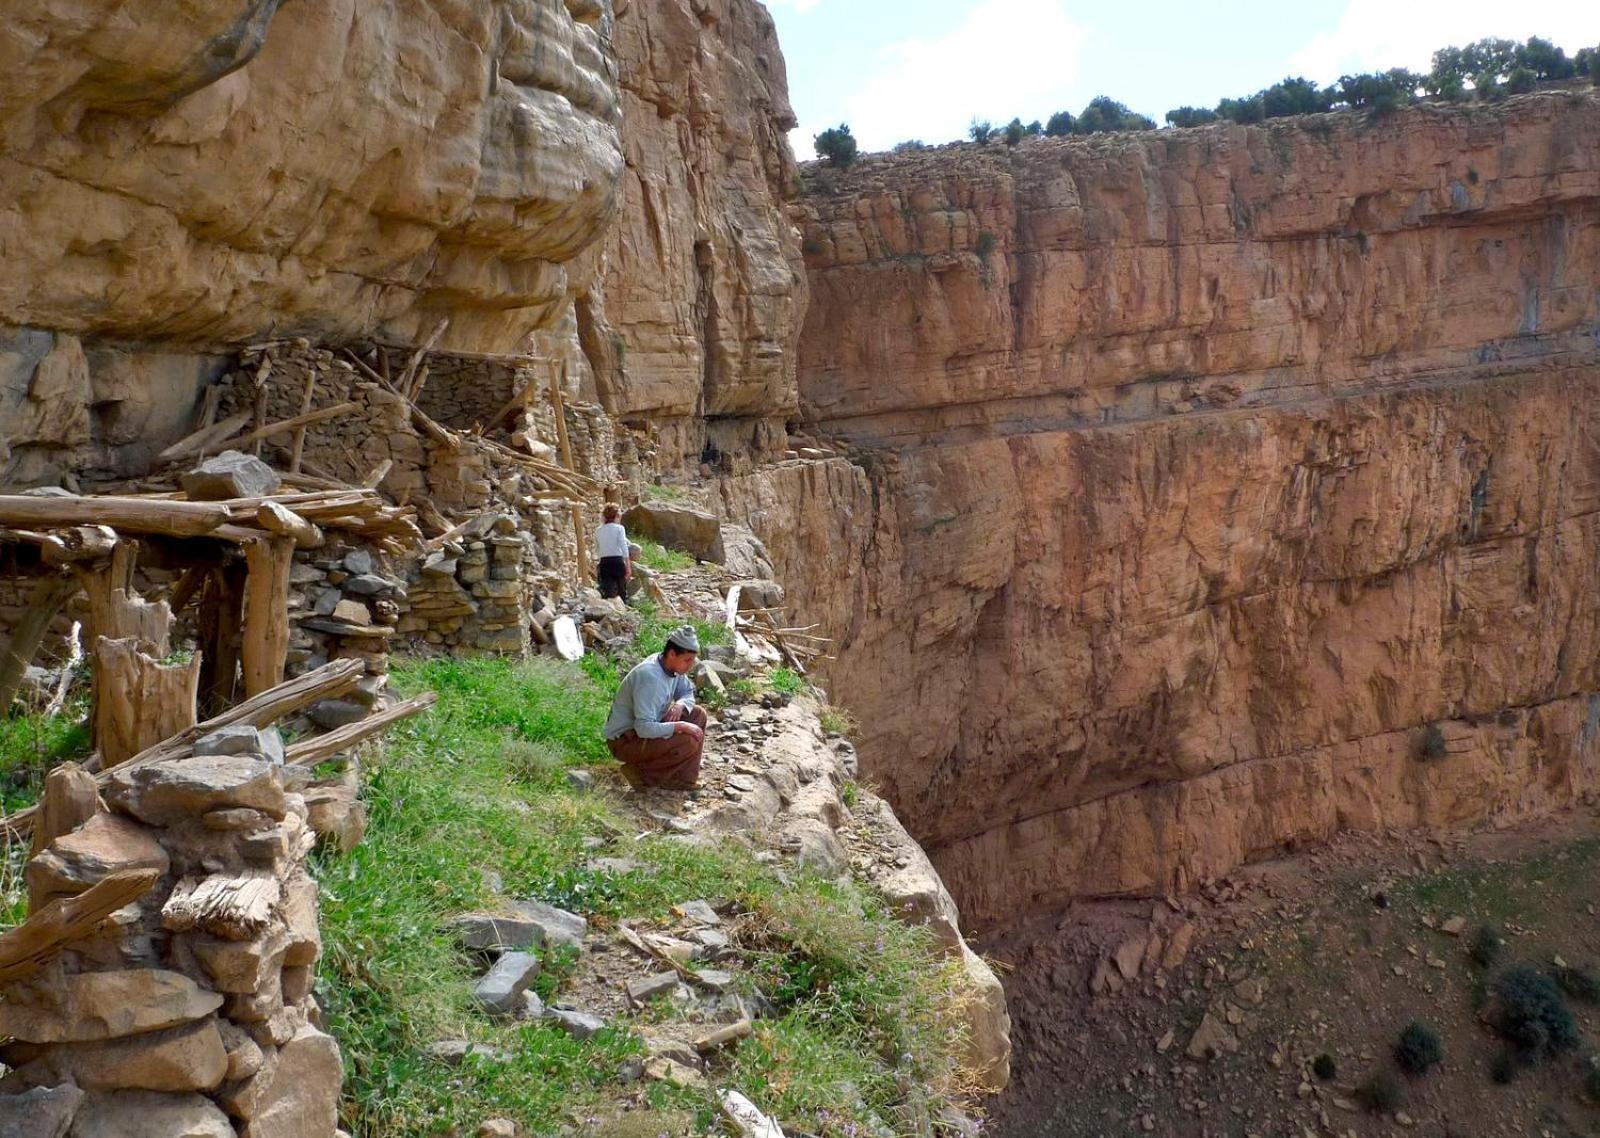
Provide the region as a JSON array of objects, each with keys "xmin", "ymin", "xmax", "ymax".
[{"xmin": 605, "ymin": 624, "xmax": 706, "ymax": 791}]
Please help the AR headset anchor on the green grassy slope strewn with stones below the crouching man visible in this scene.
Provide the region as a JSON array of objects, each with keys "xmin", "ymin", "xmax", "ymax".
[{"xmin": 318, "ymin": 661, "xmax": 960, "ymax": 1138}]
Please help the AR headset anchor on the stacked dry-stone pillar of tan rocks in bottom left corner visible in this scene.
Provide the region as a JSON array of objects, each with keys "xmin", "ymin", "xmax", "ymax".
[{"xmin": 0, "ymin": 727, "xmax": 347, "ymax": 1138}]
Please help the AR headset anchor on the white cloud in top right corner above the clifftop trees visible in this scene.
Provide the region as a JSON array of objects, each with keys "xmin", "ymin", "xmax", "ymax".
[{"xmin": 1288, "ymin": 0, "xmax": 1600, "ymax": 83}]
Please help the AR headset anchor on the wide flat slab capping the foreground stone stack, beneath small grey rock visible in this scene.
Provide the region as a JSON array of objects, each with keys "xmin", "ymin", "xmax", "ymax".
[{"xmin": 106, "ymin": 754, "xmax": 288, "ymax": 826}]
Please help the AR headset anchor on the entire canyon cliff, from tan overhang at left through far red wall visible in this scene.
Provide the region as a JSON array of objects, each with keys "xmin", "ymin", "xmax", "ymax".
[{"xmin": 0, "ymin": 0, "xmax": 1600, "ymax": 1133}]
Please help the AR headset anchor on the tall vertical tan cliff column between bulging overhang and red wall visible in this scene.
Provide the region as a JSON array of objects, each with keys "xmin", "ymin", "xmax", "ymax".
[{"xmin": 578, "ymin": 0, "xmax": 806, "ymax": 461}]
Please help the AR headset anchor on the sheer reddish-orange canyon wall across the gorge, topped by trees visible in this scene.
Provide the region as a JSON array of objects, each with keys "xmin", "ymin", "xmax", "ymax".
[{"xmin": 777, "ymin": 93, "xmax": 1600, "ymax": 922}]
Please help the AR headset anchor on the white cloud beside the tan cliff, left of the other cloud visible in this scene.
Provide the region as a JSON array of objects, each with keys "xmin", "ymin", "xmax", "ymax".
[{"xmin": 825, "ymin": 0, "xmax": 1085, "ymax": 150}]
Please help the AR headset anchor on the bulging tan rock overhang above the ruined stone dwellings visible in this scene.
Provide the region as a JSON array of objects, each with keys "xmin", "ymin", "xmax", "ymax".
[{"xmin": 0, "ymin": 0, "xmax": 622, "ymax": 480}]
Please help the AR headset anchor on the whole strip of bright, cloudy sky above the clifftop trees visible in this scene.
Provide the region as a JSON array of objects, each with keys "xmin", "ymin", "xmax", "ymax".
[{"xmin": 765, "ymin": 0, "xmax": 1600, "ymax": 158}]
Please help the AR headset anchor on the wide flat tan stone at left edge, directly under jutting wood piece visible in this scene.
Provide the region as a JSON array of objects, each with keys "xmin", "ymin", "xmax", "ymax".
[{"xmin": 0, "ymin": 968, "xmax": 222, "ymax": 1043}]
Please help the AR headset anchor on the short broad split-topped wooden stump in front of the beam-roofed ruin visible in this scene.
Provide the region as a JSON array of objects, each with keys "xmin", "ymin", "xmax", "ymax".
[{"xmin": 94, "ymin": 637, "xmax": 200, "ymax": 770}]
